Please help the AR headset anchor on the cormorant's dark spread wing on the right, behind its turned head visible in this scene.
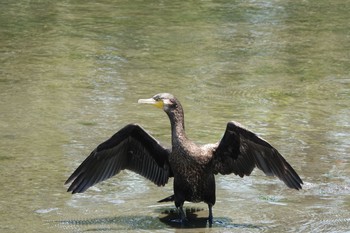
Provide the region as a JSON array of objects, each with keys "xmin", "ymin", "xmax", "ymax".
[{"xmin": 213, "ymin": 122, "xmax": 303, "ymax": 189}]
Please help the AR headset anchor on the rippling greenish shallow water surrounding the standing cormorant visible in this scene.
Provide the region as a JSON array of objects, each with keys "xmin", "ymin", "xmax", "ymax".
[{"xmin": 0, "ymin": 0, "xmax": 350, "ymax": 232}]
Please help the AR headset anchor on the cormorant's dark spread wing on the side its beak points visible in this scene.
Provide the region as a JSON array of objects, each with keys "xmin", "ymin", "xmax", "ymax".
[{"xmin": 65, "ymin": 124, "xmax": 173, "ymax": 193}]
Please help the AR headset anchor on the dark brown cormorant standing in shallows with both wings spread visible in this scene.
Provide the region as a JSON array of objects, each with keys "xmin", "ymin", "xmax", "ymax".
[{"xmin": 65, "ymin": 93, "xmax": 303, "ymax": 225}]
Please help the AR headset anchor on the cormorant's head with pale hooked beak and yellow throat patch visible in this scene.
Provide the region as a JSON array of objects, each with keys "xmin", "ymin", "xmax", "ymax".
[{"xmin": 138, "ymin": 93, "xmax": 179, "ymax": 112}]
